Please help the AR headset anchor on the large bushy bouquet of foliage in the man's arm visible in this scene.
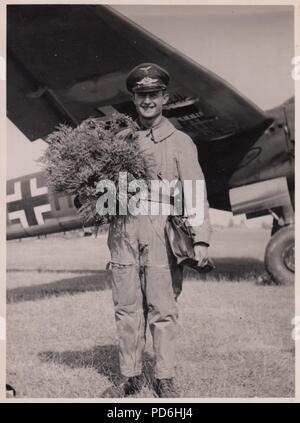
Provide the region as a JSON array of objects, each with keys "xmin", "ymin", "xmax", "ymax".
[{"xmin": 40, "ymin": 114, "xmax": 148, "ymax": 224}]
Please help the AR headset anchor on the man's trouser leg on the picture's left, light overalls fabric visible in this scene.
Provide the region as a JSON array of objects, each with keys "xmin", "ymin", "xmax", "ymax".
[{"xmin": 108, "ymin": 218, "xmax": 145, "ymax": 377}]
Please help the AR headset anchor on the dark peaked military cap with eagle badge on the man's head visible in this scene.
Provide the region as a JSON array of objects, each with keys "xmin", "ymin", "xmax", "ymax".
[{"xmin": 126, "ymin": 63, "xmax": 170, "ymax": 92}]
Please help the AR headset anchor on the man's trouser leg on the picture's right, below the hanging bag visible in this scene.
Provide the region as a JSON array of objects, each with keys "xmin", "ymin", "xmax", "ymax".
[{"xmin": 140, "ymin": 216, "xmax": 179, "ymax": 379}]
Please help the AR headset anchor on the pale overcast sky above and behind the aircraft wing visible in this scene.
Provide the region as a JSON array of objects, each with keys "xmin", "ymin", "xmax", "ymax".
[{"xmin": 7, "ymin": 5, "xmax": 294, "ymax": 225}]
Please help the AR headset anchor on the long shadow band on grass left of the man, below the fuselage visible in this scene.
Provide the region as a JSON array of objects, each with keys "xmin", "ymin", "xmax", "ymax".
[{"xmin": 6, "ymin": 270, "xmax": 111, "ymax": 303}]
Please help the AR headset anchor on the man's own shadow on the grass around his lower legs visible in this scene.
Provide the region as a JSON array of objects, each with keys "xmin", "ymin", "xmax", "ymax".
[{"xmin": 38, "ymin": 345, "xmax": 155, "ymax": 386}]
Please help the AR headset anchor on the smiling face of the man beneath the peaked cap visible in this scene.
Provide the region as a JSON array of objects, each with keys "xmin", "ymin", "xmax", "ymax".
[{"xmin": 133, "ymin": 90, "xmax": 169, "ymax": 121}]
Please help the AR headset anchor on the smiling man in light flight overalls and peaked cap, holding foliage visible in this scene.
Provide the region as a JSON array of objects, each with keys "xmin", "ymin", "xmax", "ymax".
[{"xmin": 103, "ymin": 63, "xmax": 211, "ymax": 397}]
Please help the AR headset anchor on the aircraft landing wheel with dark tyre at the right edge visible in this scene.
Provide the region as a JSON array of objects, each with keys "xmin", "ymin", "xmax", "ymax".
[{"xmin": 265, "ymin": 225, "xmax": 295, "ymax": 285}]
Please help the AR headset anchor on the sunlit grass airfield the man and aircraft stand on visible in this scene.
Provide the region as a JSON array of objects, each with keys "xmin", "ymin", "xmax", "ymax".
[{"xmin": 7, "ymin": 228, "xmax": 294, "ymax": 398}]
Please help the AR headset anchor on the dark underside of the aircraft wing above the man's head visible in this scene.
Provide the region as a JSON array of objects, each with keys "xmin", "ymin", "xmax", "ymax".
[{"xmin": 7, "ymin": 5, "xmax": 270, "ymax": 209}]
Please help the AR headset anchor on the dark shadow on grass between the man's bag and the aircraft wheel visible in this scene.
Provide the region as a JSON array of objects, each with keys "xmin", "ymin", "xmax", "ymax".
[{"xmin": 184, "ymin": 257, "xmax": 265, "ymax": 282}]
